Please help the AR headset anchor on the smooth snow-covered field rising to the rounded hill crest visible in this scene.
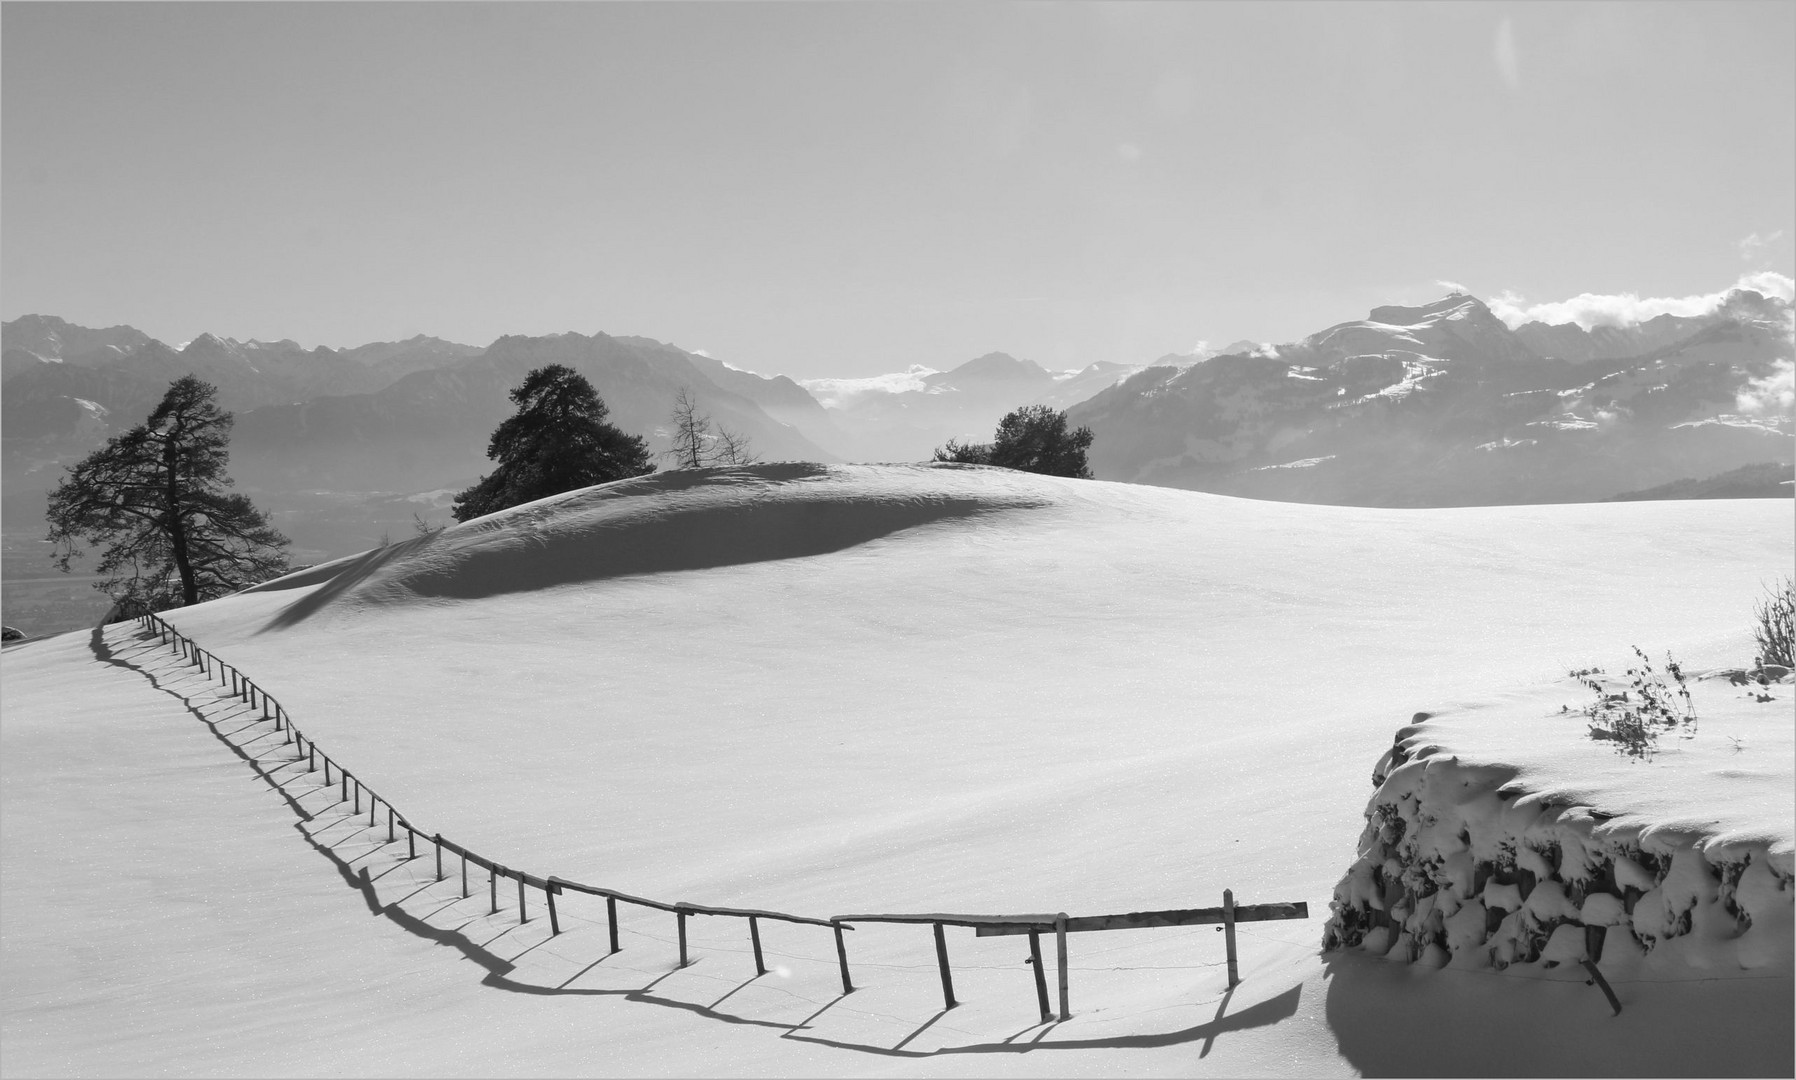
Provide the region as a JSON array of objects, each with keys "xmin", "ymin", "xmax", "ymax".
[{"xmin": 0, "ymin": 465, "xmax": 1796, "ymax": 1076}]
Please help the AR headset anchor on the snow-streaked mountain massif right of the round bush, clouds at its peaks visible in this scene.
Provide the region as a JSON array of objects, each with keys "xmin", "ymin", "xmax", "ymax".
[{"xmin": 1069, "ymin": 289, "xmax": 1792, "ymax": 507}]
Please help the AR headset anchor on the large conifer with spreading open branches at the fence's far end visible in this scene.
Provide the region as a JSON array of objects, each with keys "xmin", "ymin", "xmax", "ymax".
[{"xmin": 47, "ymin": 376, "xmax": 287, "ymax": 615}]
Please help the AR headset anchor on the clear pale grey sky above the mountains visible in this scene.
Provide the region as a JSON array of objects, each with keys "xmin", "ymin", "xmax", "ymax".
[{"xmin": 0, "ymin": 2, "xmax": 1796, "ymax": 377}]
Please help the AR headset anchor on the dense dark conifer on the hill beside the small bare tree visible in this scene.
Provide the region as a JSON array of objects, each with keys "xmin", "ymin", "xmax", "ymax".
[{"xmin": 453, "ymin": 363, "xmax": 656, "ymax": 521}]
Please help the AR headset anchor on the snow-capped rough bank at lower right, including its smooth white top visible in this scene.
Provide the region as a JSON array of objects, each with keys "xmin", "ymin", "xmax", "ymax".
[{"xmin": 1324, "ymin": 672, "xmax": 1796, "ymax": 979}]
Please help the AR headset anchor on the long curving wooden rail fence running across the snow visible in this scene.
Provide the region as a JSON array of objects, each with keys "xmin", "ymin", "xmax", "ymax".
[{"xmin": 136, "ymin": 615, "xmax": 1309, "ymax": 1022}]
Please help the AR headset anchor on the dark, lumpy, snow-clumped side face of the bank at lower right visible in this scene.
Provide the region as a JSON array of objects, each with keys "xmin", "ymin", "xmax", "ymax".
[{"xmin": 1324, "ymin": 713, "xmax": 1796, "ymax": 976}]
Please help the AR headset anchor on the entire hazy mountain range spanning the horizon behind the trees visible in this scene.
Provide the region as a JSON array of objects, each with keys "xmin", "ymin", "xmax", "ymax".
[{"xmin": 0, "ymin": 289, "xmax": 1792, "ymax": 555}]
